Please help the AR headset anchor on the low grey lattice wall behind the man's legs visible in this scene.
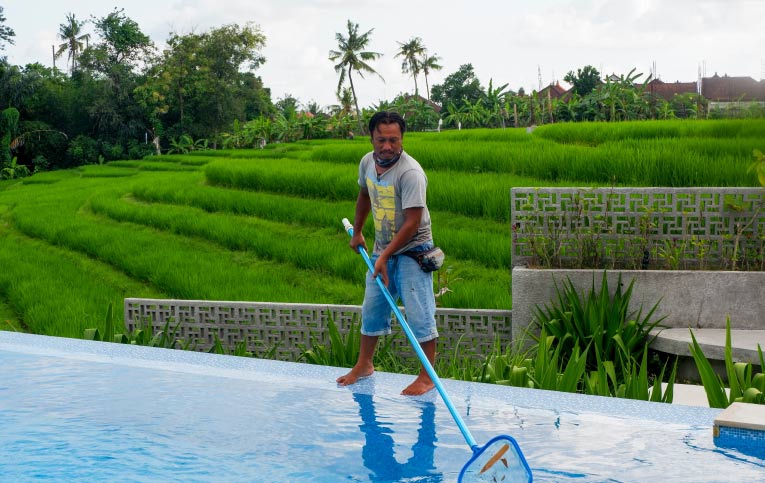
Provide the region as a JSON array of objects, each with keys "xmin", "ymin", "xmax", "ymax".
[{"xmin": 125, "ymin": 298, "xmax": 512, "ymax": 360}]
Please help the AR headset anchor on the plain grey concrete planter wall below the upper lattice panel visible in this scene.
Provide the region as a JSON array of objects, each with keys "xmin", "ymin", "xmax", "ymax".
[{"xmin": 512, "ymin": 267, "xmax": 765, "ymax": 341}]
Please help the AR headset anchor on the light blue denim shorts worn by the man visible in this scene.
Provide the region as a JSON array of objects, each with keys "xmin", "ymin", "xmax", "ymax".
[{"xmin": 361, "ymin": 243, "xmax": 438, "ymax": 342}]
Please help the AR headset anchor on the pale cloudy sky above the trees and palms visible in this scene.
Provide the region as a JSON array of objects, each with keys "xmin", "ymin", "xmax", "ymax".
[{"xmin": 0, "ymin": 0, "xmax": 765, "ymax": 106}]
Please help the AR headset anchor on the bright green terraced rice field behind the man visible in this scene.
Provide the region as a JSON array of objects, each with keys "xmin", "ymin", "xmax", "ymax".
[{"xmin": 0, "ymin": 120, "xmax": 765, "ymax": 338}]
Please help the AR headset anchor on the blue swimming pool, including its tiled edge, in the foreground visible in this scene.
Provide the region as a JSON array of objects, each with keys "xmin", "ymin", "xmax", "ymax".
[{"xmin": 0, "ymin": 332, "xmax": 765, "ymax": 483}]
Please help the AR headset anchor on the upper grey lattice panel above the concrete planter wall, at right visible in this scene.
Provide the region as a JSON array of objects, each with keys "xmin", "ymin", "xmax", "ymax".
[{"xmin": 510, "ymin": 188, "xmax": 765, "ymax": 270}]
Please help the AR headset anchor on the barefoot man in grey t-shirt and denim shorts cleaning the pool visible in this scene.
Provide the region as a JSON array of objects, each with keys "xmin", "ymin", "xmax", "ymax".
[{"xmin": 337, "ymin": 111, "xmax": 438, "ymax": 396}]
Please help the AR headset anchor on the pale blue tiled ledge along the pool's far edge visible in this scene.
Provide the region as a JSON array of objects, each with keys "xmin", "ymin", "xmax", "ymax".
[{"xmin": 0, "ymin": 331, "xmax": 720, "ymax": 420}]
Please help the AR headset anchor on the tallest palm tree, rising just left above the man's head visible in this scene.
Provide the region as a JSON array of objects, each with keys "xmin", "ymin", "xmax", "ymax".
[{"xmin": 329, "ymin": 20, "xmax": 385, "ymax": 133}]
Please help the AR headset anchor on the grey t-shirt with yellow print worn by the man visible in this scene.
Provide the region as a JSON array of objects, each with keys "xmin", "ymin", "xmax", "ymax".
[{"xmin": 359, "ymin": 152, "xmax": 433, "ymax": 255}]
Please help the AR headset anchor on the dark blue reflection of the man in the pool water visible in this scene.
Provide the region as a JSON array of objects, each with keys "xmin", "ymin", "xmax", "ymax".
[{"xmin": 353, "ymin": 393, "xmax": 443, "ymax": 483}]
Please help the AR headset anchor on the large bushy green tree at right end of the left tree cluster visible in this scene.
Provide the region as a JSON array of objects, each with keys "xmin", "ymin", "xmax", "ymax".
[{"xmin": 135, "ymin": 23, "xmax": 274, "ymax": 145}]
